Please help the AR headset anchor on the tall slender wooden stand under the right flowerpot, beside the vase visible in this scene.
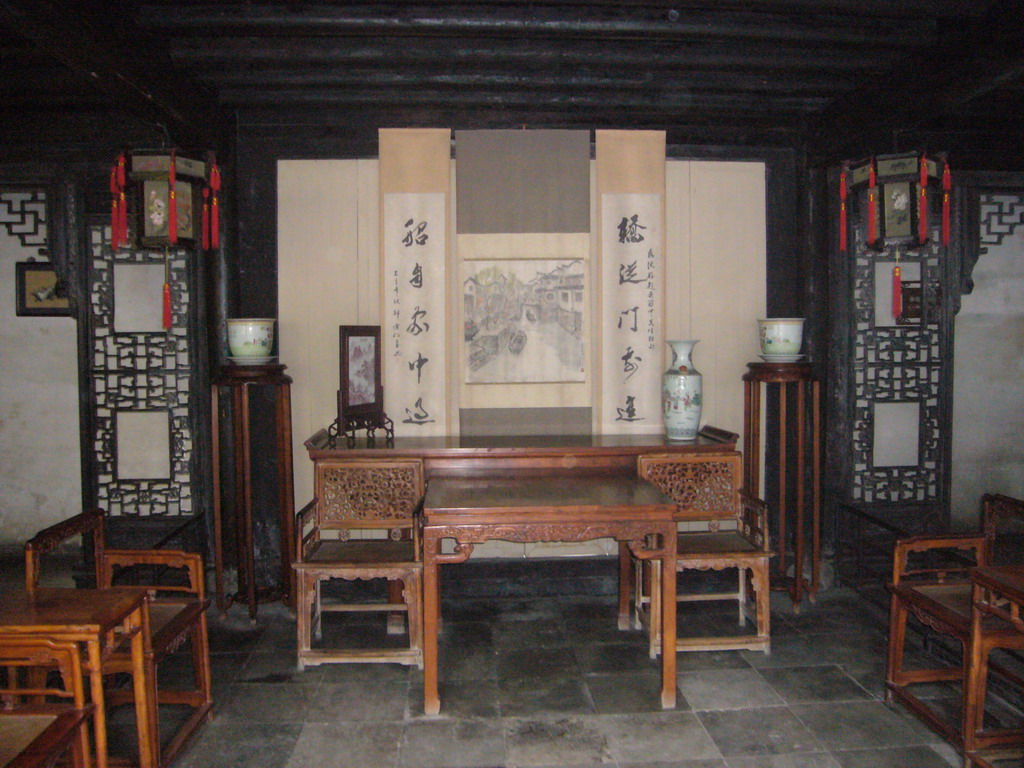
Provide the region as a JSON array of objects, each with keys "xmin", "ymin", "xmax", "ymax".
[{"xmin": 743, "ymin": 362, "xmax": 821, "ymax": 611}]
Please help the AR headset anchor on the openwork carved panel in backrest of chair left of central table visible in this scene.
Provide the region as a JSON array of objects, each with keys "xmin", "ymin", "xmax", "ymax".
[{"xmin": 316, "ymin": 461, "xmax": 423, "ymax": 527}]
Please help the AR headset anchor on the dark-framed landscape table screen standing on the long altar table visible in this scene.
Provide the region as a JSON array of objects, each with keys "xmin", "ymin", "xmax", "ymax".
[{"xmin": 338, "ymin": 326, "xmax": 385, "ymax": 426}]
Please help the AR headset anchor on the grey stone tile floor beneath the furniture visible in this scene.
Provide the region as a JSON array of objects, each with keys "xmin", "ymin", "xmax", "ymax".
[{"xmin": 2, "ymin": 561, "xmax": 1015, "ymax": 768}]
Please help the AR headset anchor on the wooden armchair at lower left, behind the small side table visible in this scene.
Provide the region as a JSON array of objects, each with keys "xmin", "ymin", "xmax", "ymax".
[{"xmin": 25, "ymin": 509, "xmax": 213, "ymax": 768}]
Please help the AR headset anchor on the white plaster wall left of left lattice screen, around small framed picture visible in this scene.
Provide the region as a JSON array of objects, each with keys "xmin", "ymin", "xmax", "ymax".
[{"xmin": 0, "ymin": 227, "xmax": 82, "ymax": 551}]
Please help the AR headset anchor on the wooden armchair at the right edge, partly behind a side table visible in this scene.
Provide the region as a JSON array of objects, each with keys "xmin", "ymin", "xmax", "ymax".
[{"xmin": 886, "ymin": 494, "xmax": 1024, "ymax": 765}]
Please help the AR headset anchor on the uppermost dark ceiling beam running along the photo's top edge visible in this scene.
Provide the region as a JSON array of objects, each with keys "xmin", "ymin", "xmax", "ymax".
[{"xmin": 136, "ymin": 3, "xmax": 934, "ymax": 46}]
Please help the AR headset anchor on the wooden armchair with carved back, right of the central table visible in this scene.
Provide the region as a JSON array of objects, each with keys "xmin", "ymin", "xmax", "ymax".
[{"xmin": 620, "ymin": 451, "xmax": 772, "ymax": 657}]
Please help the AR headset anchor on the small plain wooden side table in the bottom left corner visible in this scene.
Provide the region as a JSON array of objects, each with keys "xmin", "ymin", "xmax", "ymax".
[{"xmin": 0, "ymin": 587, "xmax": 157, "ymax": 768}]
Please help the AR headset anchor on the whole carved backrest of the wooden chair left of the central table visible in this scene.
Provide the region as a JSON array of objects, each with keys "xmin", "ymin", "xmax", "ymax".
[{"xmin": 302, "ymin": 459, "xmax": 424, "ymax": 551}]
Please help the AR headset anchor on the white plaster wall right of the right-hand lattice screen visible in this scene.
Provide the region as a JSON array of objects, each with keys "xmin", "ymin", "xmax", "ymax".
[{"xmin": 950, "ymin": 219, "xmax": 1024, "ymax": 528}]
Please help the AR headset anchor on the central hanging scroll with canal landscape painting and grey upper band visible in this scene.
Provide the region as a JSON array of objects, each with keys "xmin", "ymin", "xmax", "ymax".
[{"xmin": 454, "ymin": 130, "xmax": 593, "ymax": 434}]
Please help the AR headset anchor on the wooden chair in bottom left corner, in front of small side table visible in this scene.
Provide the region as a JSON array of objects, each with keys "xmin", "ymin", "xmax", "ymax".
[{"xmin": 0, "ymin": 635, "xmax": 92, "ymax": 768}]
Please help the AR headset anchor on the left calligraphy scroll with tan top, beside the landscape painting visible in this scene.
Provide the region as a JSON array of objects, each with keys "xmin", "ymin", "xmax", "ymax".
[{"xmin": 380, "ymin": 129, "xmax": 451, "ymax": 436}]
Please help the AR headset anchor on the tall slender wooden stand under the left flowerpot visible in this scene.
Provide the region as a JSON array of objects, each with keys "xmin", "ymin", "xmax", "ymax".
[{"xmin": 210, "ymin": 365, "xmax": 295, "ymax": 623}]
